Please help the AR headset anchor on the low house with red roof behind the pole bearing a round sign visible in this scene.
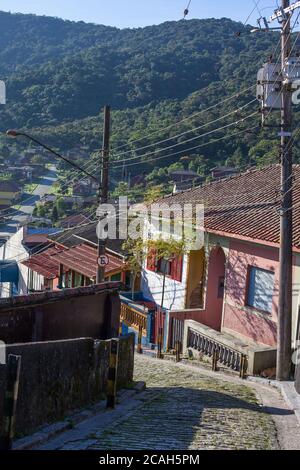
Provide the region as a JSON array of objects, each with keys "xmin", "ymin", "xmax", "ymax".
[{"xmin": 22, "ymin": 220, "xmax": 130, "ymax": 290}]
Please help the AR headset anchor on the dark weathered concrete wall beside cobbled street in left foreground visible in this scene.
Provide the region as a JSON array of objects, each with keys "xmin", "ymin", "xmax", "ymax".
[{"xmin": 0, "ymin": 335, "xmax": 134, "ymax": 436}]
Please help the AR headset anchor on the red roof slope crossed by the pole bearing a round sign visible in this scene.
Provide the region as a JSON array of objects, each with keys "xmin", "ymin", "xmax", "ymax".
[{"xmin": 53, "ymin": 244, "xmax": 124, "ymax": 278}]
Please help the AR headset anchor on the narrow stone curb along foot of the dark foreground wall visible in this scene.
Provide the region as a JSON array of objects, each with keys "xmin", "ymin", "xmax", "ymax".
[{"xmin": 13, "ymin": 382, "xmax": 146, "ymax": 450}]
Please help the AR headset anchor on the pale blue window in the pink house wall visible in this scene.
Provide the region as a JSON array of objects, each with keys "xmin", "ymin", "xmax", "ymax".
[{"xmin": 247, "ymin": 266, "xmax": 275, "ymax": 313}]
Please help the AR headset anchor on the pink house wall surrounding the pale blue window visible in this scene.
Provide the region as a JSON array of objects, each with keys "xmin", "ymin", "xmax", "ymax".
[{"xmin": 222, "ymin": 240, "xmax": 279, "ymax": 346}]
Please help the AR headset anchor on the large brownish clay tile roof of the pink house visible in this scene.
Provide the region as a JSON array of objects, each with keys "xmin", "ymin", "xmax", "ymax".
[{"xmin": 159, "ymin": 165, "xmax": 300, "ymax": 248}]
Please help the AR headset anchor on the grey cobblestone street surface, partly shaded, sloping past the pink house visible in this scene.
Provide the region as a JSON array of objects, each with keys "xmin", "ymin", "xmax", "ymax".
[{"xmin": 53, "ymin": 355, "xmax": 278, "ymax": 450}]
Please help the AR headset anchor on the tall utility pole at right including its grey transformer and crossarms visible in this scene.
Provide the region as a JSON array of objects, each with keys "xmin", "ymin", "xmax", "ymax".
[{"xmin": 253, "ymin": 0, "xmax": 300, "ymax": 381}]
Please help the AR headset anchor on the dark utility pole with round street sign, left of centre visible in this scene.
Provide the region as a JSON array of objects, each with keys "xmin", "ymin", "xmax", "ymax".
[{"xmin": 97, "ymin": 106, "xmax": 110, "ymax": 284}]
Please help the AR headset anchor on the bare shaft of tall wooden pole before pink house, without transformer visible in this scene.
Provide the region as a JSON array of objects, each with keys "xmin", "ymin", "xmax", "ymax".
[{"xmin": 277, "ymin": 0, "xmax": 293, "ymax": 381}]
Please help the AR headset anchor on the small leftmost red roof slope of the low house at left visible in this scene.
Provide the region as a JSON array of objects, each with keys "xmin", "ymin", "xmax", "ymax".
[{"xmin": 22, "ymin": 247, "xmax": 61, "ymax": 279}]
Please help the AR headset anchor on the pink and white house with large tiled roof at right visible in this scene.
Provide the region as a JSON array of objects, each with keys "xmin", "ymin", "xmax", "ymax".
[{"xmin": 142, "ymin": 165, "xmax": 300, "ymax": 374}]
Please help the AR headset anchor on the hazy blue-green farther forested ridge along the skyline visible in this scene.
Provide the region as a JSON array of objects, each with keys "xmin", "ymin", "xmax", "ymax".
[{"xmin": 0, "ymin": 13, "xmax": 272, "ymax": 127}]
